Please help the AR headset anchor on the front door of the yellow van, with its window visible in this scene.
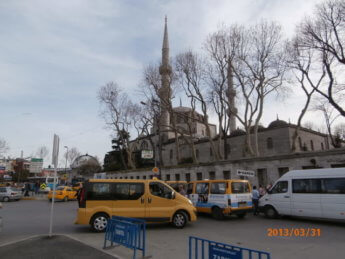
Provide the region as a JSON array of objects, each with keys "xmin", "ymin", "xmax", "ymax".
[{"xmin": 146, "ymin": 182, "xmax": 176, "ymax": 222}]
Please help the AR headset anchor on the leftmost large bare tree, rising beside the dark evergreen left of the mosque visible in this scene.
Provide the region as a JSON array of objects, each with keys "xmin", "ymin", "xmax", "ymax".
[{"xmin": 98, "ymin": 82, "xmax": 136, "ymax": 168}]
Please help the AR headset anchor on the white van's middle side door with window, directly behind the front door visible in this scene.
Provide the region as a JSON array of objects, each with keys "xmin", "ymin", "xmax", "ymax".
[{"xmin": 291, "ymin": 179, "xmax": 322, "ymax": 218}]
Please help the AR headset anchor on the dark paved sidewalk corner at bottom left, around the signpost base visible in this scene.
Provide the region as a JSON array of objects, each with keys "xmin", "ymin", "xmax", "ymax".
[{"xmin": 0, "ymin": 235, "xmax": 117, "ymax": 259}]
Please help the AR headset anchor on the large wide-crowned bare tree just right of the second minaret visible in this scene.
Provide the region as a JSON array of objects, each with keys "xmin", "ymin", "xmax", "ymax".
[{"xmin": 229, "ymin": 21, "xmax": 286, "ymax": 156}]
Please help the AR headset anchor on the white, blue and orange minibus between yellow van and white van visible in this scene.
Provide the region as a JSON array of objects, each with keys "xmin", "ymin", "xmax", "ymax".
[{"xmin": 187, "ymin": 180, "xmax": 253, "ymax": 219}]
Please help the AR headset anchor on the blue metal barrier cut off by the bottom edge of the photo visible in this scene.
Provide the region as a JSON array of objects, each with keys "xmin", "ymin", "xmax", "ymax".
[{"xmin": 189, "ymin": 236, "xmax": 271, "ymax": 259}]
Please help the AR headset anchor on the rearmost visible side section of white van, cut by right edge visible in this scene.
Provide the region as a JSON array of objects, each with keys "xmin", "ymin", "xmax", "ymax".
[{"xmin": 321, "ymin": 178, "xmax": 345, "ymax": 219}]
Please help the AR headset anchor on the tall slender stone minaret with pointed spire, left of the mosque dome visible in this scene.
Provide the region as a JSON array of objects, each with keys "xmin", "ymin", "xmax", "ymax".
[{"xmin": 158, "ymin": 16, "xmax": 171, "ymax": 140}]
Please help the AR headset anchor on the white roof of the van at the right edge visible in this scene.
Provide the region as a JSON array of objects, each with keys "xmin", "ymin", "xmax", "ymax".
[{"xmin": 280, "ymin": 167, "xmax": 345, "ymax": 179}]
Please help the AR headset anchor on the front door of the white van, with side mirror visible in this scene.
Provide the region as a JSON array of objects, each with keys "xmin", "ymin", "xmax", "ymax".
[{"xmin": 262, "ymin": 180, "xmax": 291, "ymax": 215}]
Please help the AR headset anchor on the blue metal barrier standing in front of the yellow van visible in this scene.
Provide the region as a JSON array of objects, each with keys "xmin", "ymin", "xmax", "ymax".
[{"xmin": 103, "ymin": 216, "xmax": 146, "ymax": 259}]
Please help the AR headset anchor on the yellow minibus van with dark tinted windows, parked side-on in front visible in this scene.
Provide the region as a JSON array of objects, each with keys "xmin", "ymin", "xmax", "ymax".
[{"xmin": 75, "ymin": 179, "xmax": 196, "ymax": 232}]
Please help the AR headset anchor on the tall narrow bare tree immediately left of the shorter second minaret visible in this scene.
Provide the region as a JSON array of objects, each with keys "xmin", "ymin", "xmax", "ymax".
[{"xmin": 204, "ymin": 25, "xmax": 244, "ymax": 159}]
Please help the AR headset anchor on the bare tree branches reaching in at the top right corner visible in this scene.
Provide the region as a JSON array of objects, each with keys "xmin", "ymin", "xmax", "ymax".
[{"xmin": 298, "ymin": 0, "xmax": 345, "ymax": 116}]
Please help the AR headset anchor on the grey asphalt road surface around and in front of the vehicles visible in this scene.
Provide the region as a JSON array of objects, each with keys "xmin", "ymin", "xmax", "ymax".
[{"xmin": 0, "ymin": 201, "xmax": 345, "ymax": 259}]
